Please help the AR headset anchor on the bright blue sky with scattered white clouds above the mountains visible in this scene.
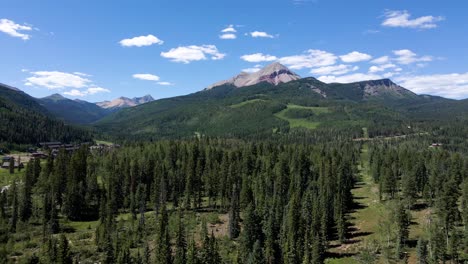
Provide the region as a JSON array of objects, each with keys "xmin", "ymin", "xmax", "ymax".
[{"xmin": 0, "ymin": 0, "xmax": 468, "ymax": 102}]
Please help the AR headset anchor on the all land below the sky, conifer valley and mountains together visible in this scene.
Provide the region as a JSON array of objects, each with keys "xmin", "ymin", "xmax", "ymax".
[{"xmin": 0, "ymin": 63, "xmax": 468, "ymax": 264}]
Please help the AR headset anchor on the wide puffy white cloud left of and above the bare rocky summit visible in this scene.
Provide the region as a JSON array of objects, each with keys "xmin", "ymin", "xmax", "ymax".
[{"xmin": 161, "ymin": 45, "xmax": 226, "ymax": 63}]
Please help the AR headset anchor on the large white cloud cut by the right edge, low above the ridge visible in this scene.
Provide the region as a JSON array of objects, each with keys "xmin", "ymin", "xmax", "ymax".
[{"xmin": 395, "ymin": 72, "xmax": 468, "ymax": 99}]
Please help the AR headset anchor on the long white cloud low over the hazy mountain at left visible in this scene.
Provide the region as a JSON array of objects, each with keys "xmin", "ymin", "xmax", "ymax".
[{"xmin": 26, "ymin": 71, "xmax": 91, "ymax": 89}]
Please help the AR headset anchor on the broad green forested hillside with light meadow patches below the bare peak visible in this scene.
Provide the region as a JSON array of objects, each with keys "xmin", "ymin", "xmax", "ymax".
[{"xmin": 96, "ymin": 78, "xmax": 468, "ymax": 139}]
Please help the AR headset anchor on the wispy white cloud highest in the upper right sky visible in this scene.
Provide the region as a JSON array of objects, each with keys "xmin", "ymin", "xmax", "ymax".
[{"xmin": 382, "ymin": 10, "xmax": 444, "ymax": 29}]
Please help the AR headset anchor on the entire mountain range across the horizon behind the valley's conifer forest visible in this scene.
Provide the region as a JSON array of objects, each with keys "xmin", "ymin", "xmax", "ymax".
[{"xmin": 0, "ymin": 63, "xmax": 468, "ymax": 142}]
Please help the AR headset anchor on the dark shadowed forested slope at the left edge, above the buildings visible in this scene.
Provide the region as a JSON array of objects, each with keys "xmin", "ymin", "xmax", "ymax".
[{"xmin": 0, "ymin": 85, "xmax": 92, "ymax": 147}]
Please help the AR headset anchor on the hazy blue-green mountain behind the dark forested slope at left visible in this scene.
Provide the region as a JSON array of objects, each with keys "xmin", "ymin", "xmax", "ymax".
[{"xmin": 38, "ymin": 94, "xmax": 110, "ymax": 124}]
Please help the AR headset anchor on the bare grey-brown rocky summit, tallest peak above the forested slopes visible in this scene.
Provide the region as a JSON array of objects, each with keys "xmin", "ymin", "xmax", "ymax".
[{"xmin": 206, "ymin": 62, "xmax": 301, "ymax": 90}]
